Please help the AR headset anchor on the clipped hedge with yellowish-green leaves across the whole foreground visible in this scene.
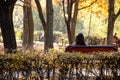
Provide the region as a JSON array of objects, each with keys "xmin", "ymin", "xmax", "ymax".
[{"xmin": 0, "ymin": 50, "xmax": 120, "ymax": 80}]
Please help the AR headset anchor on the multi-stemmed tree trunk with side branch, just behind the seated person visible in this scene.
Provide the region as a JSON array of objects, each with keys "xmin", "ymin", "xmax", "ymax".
[{"xmin": 62, "ymin": 0, "xmax": 97, "ymax": 44}]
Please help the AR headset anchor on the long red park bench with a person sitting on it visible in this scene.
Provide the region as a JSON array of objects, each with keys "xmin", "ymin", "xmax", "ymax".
[{"xmin": 65, "ymin": 45, "xmax": 118, "ymax": 53}]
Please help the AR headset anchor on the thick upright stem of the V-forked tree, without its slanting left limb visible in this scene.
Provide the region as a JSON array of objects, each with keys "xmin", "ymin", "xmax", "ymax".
[{"xmin": 44, "ymin": 0, "xmax": 53, "ymax": 50}]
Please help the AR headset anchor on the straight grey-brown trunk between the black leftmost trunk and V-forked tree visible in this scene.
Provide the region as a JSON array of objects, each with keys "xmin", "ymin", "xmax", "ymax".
[{"xmin": 23, "ymin": 0, "xmax": 34, "ymax": 50}]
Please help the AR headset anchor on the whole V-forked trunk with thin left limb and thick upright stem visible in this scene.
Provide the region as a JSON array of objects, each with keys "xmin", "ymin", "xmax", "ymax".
[{"xmin": 35, "ymin": 0, "xmax": 53, "ymax": 51}]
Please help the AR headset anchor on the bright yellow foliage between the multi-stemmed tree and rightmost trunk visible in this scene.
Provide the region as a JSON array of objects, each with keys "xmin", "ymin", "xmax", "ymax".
[{"xmin": 79, "ymin": 0, "xmax": 108, "ymax": 17}]
